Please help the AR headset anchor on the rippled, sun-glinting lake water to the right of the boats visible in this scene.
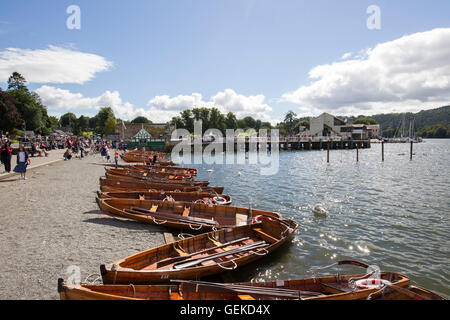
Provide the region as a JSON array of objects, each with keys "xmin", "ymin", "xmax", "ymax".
[{"xmin": 174, "ymin": 140, "xmax": 450, "ymax": 297}]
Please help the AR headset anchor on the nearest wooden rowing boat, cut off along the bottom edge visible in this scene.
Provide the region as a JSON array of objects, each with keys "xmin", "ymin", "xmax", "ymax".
[{"xmin": 58, "ymin": 261, "xmax": 410, "ymax": 300}]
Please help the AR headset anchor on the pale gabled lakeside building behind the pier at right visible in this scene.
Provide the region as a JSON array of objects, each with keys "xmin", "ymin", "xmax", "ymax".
[{"xmin": 308, "ymin": 112, "xmax": 381, "ymax": 140}]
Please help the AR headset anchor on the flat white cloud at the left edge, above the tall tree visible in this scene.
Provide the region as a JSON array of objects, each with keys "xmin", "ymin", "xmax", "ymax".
[{"xmin": 0, "ymin": 46, "xmax": 112, "ymax": 84}]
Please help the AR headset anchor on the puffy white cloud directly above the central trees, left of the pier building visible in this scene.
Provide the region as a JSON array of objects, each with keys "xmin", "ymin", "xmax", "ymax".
[{"xmin": 147, "ymin": 89, "xmax": 272, "ymax": 121}]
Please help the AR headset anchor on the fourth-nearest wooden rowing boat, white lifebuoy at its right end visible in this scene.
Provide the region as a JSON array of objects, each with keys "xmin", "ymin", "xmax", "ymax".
[{"xmin": 97, "ymin": 191, "xmax": 232, "ymax": 205}]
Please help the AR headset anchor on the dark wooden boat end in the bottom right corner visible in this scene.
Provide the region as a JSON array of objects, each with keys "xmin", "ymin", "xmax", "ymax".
[{"xmin": 368, "ymin": 285, "xmax": 447, "ymax": 300}]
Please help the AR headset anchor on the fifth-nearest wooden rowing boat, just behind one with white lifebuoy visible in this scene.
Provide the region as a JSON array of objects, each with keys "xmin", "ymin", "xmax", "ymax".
[{"xmin": 100, "ymin": 177, "xmax": 224, "ymax": 194}]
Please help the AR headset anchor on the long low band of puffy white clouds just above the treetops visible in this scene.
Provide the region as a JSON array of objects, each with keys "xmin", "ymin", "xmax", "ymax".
[{"xmin": 36, "ymin": 85, "xmax": 272, "ymax": 122}]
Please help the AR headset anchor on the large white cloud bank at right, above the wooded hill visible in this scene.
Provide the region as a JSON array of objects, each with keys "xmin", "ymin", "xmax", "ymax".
[{"xmin": 282, "ymin": 28, "xmax": 450, "ymax": 115}]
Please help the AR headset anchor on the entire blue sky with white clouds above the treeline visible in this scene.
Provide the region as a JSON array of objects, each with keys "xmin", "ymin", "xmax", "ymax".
[{"xmin": 0, "ymin": 0, "xmax": 450, "ymax": 123}]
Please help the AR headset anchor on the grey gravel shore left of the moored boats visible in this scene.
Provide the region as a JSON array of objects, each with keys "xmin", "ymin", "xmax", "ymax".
[{"xmin": 0, "ymin": 156, "xmax": 166, "ymax": 299}]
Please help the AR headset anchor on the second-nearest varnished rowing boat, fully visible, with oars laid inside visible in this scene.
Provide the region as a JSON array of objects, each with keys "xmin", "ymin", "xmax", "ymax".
[{"xmin": 100, "ymin": 218, "xmax": 298, "ymax": 284}]
